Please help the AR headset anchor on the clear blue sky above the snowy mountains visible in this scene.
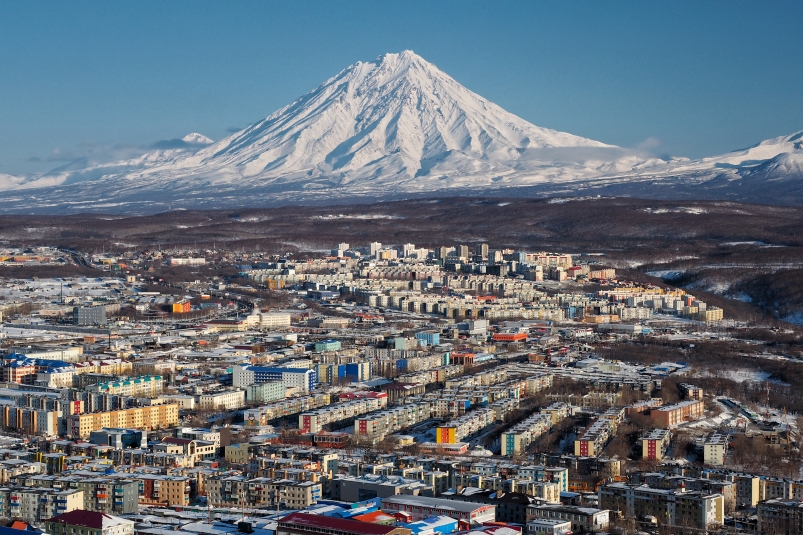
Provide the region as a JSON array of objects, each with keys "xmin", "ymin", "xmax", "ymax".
[{"xmin": 0, "ymin": 1, "xmax": 803, "ymax": 173}]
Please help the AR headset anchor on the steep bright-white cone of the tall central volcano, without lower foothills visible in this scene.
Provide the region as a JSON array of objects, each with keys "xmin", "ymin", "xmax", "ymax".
[{"xmin": 186, "ymin": 51, "xmax": 608, "ymax": 183}]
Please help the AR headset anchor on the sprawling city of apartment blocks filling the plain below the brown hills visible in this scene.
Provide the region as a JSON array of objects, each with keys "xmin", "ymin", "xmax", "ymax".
[{"xmin": 0, "ymin": 243, "xmax": 792, "ymax": 535}]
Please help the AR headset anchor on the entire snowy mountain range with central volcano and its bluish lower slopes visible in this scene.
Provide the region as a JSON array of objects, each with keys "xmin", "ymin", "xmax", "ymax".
[{"xmin": 0, "ymin": 51, "xmax": 803, "ymax": 213}]
